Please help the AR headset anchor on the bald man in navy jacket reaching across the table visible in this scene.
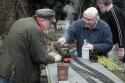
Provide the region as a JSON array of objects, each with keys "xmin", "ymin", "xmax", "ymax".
[{"xmin": 57, "ymin": 7, "xmax": 113, "ymax": 57}]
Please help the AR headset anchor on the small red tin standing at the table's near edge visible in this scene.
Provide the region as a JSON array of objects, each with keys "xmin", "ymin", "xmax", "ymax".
[{"xmin": 57, "ymin": 63, "xmax": 69, "ymax": 81}]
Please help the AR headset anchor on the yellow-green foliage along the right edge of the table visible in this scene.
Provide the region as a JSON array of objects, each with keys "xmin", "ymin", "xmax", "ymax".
[{"xmin": 98, "ymin": 56, "xmax": 125, "ymax": 82}]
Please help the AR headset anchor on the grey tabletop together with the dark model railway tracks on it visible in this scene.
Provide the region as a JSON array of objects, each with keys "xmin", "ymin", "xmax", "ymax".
[{"xmin": 46, "ymin": 58, "xmax": 124, "ymax": 83}]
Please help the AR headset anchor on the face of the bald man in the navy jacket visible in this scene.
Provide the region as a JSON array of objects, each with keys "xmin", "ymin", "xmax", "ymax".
[{"xmin": 84, "ymin": 14, "xmax": 97, "ymax": 29}]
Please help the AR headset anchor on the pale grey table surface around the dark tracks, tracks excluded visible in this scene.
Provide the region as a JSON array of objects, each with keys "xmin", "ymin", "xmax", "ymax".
[{"xmin": 46, "ymin": 58, "xmax": 124, "ymax": 83}]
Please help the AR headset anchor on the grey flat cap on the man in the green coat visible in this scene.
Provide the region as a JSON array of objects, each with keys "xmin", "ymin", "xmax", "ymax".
[{"xmin": 35, "ymin": 8, "xmax": 56, "ymax": 22}]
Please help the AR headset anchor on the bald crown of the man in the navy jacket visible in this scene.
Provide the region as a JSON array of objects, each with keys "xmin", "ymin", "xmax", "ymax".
[{"xmin": 83, "ymin": 7, "xmax": 99, "ymax": 20}]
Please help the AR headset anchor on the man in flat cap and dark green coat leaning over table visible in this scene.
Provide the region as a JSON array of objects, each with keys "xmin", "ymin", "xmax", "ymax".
[{"xmin": 0, "ymin": 9, "xmax": 61, "ymax": 83}]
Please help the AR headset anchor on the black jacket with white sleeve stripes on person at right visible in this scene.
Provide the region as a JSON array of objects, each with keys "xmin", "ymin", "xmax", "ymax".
[{"xmin": 101, "ymin": 5, "xmax": 125, "ymax": 48}]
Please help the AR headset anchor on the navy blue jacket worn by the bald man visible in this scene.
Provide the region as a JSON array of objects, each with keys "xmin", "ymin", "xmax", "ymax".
[{"xmin": 65, "ymin": 19, "xmax": 113, "ymax": 56}]
